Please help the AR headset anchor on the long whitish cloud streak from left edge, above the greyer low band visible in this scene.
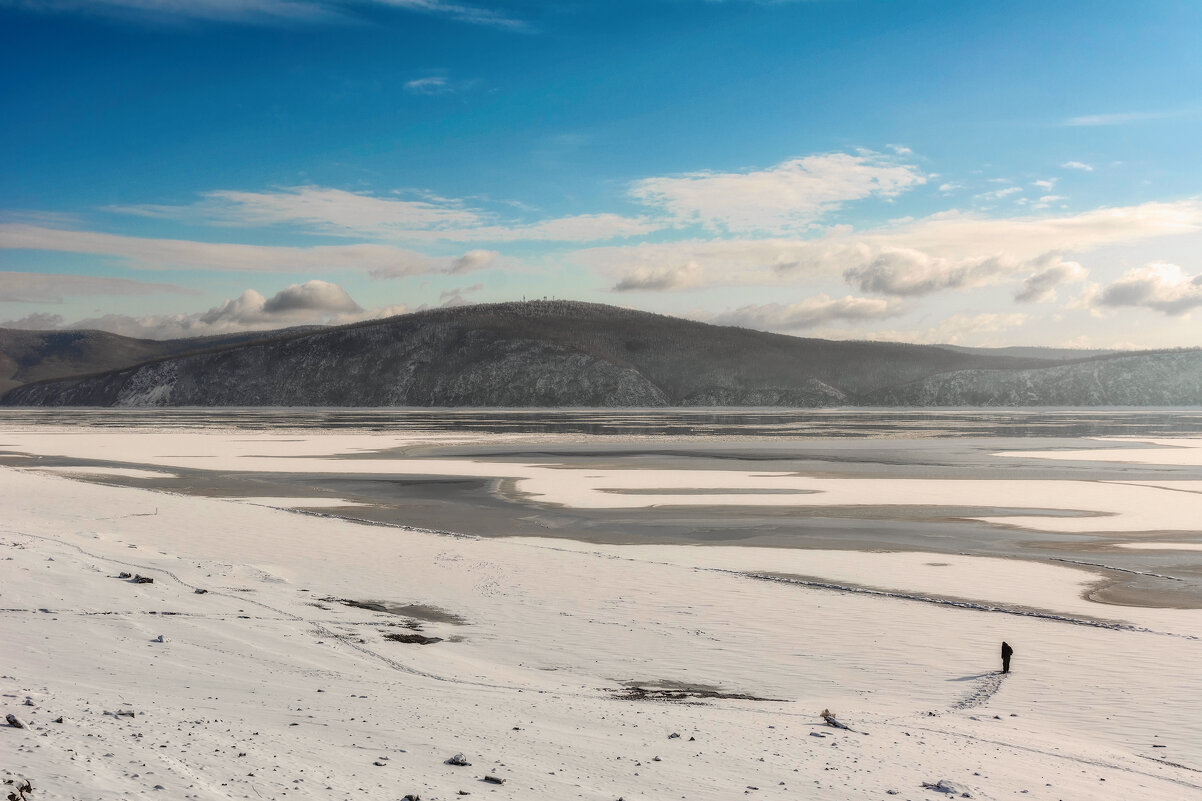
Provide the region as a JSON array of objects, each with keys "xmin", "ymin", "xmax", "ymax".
[{"xmin": 0, "ymin": 223, "xmax": 502, "ymax": 278}]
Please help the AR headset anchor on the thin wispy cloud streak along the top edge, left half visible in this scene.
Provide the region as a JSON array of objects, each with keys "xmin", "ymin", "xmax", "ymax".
[{"xmin": 0, "ymin": 0, "xmax": 526, "ymax": 30}]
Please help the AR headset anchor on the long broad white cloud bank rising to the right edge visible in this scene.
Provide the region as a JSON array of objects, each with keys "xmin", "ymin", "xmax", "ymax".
[{"xmin": 586, "ymin": 200, "xmax": 1202, "ymax": 296}]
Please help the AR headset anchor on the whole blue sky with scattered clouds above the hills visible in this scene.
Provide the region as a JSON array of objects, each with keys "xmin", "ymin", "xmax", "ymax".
[{"xmin": 0, "ymin": 0, "xmax": 1202, "ymax": 348}]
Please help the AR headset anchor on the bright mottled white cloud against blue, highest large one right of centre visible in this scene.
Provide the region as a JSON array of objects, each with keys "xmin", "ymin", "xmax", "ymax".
[{"xmin": 630, "ymin": 150, "xmax": 927, "ymax": 232}]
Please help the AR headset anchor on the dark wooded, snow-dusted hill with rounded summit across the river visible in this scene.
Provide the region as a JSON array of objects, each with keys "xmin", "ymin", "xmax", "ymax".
[{"xmin": 0, "ymin": 301, "xmax": 1202, "ymax": 408}]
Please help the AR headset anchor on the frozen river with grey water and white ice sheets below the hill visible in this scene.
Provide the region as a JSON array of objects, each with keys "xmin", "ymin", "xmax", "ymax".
[{"xmin": 0, "ymin": 409, "xmax": 1202, "ymax": 607}]
